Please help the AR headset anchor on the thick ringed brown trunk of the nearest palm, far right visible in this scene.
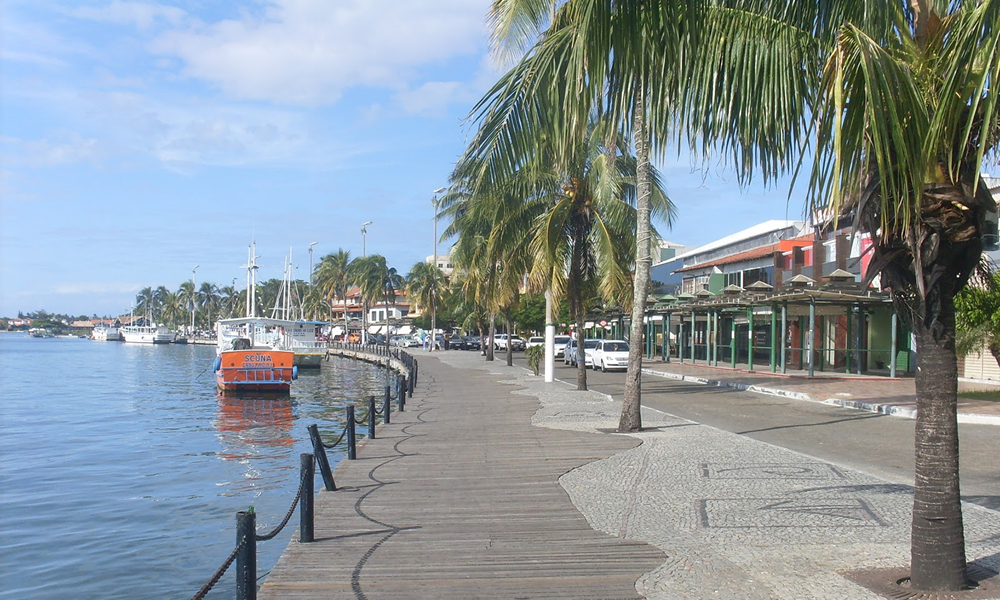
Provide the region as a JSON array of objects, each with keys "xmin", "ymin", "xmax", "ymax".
[{"xmin": 910, "ymin": 302, "xmax": 966, "ymax": 591}]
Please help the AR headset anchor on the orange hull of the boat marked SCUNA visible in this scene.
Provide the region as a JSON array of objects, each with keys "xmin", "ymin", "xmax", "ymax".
[{"xmin": 215, "ymin": 350, "xmax": 298, "ymax": 394}]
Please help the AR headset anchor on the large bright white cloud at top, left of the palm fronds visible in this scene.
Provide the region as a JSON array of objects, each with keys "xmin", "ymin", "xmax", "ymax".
[{"xmin": 151, "ymin": 0, "xmax": 488, "ymax": 106}]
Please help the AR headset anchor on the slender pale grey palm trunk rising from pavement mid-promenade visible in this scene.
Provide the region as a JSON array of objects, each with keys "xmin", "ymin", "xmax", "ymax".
[{"xmin": 618, "ymin": 84, "xmax": 652, "ymax": 433}]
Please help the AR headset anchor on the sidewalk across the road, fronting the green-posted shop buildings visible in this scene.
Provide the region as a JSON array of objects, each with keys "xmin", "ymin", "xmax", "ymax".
[{"xmin": 642, "ymin": 359, "xmax": 1000, "ymax": 425}]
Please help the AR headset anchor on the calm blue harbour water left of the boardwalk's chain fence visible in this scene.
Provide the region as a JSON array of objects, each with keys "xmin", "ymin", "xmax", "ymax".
[{"xmin": 0, "ymin": 333, "xmax": 385, "ymax": 600}]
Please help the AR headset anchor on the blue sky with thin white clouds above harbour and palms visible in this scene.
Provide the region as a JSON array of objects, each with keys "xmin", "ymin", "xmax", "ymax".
[{"xmin": 0, "ymin": 0, "xmax": 803, "ymax": 317}]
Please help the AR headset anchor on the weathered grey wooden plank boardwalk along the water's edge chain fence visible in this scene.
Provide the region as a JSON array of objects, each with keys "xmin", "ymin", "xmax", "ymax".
[{"xmin": 258, "ymin": 357, "xmax": 664, "ymax": 600}]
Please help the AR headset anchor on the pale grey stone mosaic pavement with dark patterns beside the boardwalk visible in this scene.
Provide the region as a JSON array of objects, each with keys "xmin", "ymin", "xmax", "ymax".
[{"xmin": 438, "ymin": 352, "xmax": 1000, "ymax": 600}]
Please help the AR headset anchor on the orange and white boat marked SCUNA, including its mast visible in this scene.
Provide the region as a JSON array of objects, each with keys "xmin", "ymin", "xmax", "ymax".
[{"xmin": 214, "ymin": 244, "xmax": 298, "ymax": 394}]
